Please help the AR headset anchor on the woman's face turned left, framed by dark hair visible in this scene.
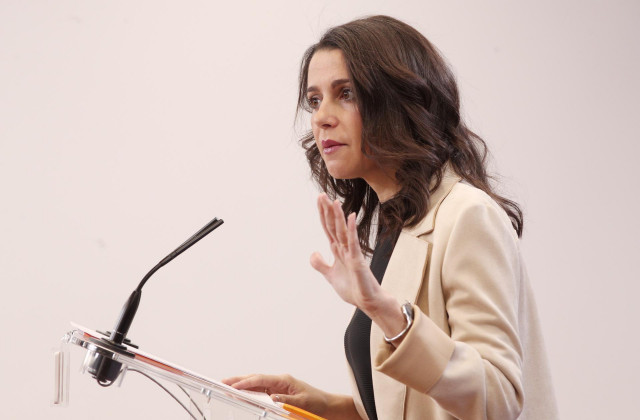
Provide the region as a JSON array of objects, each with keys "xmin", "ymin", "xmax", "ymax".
[{"xmin": 307, "ymin": 49, "xmax": 379, "ymax": 180}]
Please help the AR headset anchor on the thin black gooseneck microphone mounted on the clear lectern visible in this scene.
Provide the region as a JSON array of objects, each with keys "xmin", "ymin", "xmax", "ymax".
[{"xmin": 87, "ymin": 218, "xmax": 224, "ymax": 386}]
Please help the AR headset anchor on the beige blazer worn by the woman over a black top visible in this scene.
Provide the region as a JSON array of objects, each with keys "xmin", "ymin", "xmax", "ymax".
[{"xmin": 351, "ymin": 171, "xmax": 558, "ymax": 420}]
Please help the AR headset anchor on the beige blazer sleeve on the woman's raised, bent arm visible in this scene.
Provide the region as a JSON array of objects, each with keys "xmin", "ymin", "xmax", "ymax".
[{"xmin": 374, "ymin": 197, "xmax": 524, "ymax": 420}]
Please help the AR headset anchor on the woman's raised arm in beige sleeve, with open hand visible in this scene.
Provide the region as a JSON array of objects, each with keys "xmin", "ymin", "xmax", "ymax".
[{"xmin": 311, "ymin": 195, "xmax": 524, "ymax": 420}]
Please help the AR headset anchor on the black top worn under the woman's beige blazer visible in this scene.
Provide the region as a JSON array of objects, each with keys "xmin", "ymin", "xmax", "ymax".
[{"xmin": 344, "ymin": 228, "xmax": 400, "ymax": 420}]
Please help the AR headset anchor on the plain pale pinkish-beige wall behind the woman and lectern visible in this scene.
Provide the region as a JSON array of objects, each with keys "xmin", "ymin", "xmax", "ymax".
[{"xmin": 0, "ymin": 0, "xmax": 640, "ymax": 420}]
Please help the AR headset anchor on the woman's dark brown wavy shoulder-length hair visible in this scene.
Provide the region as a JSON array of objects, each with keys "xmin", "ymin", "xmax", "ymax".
[{"xmin": 298, "ymin": 16, "xmax": 523, "ymax": 253}]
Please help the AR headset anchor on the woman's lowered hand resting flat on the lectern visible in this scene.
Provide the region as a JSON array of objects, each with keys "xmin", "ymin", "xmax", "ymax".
[{"xmin": 222, "ymin": 374, "xmax": 360, "ymax": 419}]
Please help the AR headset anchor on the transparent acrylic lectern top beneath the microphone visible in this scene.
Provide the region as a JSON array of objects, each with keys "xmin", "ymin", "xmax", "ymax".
[{"xmin": 53, "ymin": 325, "xmax": 321, "ymax": 420}]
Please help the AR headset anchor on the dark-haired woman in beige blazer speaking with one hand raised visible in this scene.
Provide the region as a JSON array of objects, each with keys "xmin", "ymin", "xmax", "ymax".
[{"xmin": 225, "ymin": 16, "xmax": 557, "ymax": 420}]
